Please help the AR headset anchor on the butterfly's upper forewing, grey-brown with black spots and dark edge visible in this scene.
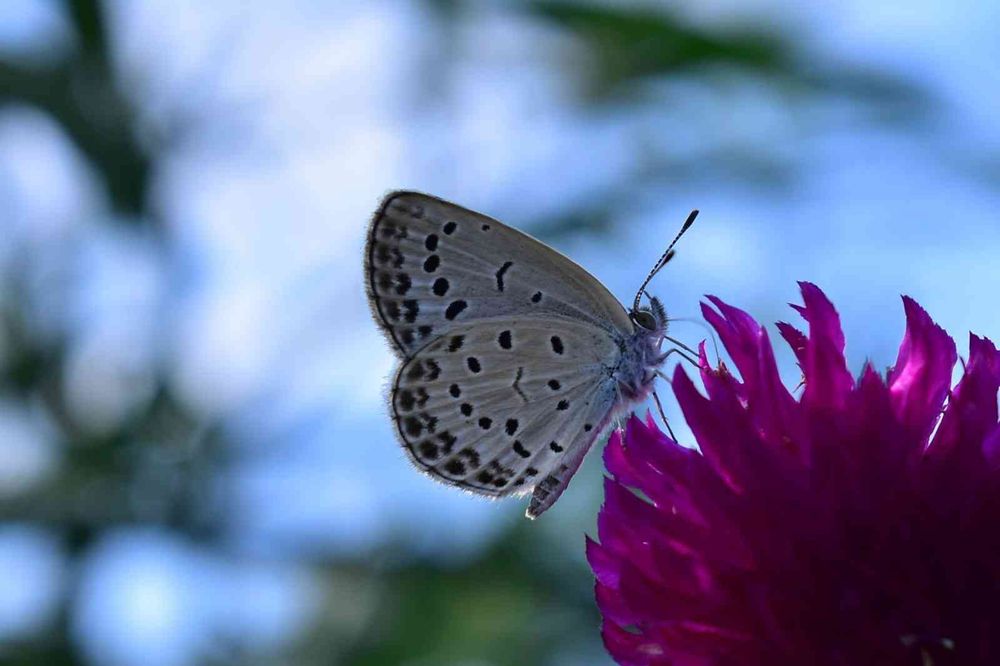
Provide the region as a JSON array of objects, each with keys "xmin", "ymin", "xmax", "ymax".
[{"xmin": 365, "ymin": 192, "xmax": 633, "ymax": 359}]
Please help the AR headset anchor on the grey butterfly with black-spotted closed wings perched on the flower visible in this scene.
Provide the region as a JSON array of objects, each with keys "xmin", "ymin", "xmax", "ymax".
[{"xmin": 364, "ymin": 191, "xmax": 698, "ymax": 518}]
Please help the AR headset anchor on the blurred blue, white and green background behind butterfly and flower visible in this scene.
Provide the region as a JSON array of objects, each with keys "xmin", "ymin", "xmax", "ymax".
[{"xmin": 0, "ymin": 0, "xmax": 1000, "ymax": 666}]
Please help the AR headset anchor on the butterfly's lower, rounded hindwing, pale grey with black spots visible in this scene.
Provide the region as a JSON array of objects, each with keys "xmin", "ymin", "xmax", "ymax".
[{"xmin": 392, "ymin": 315, "xmax": 618, "ymax": 517}]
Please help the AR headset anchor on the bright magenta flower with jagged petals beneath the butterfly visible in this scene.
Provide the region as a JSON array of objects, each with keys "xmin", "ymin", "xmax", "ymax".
[{"xmin": 587, "ymin": 283, "xmax": 1000, "ymax": 666}]
